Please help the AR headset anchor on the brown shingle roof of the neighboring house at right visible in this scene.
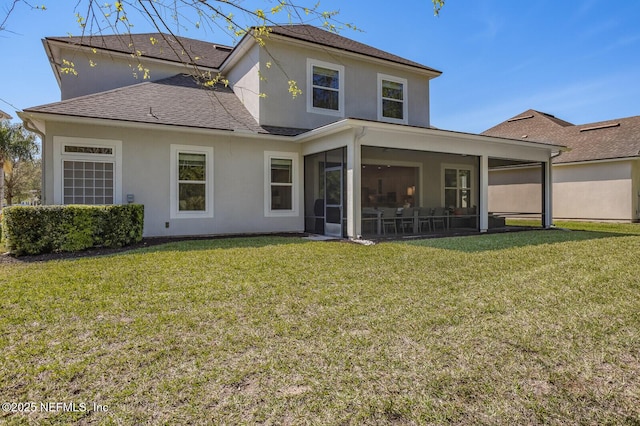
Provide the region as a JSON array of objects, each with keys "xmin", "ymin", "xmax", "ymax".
[{"xmin": 482, "ymin": 110, "xmax": 640, "ymax": 164}]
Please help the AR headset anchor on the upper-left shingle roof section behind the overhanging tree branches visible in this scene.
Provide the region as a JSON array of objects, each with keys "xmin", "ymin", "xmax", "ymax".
[{"xmin": 46, "ymin": 33, "xmax": 232, "ymax": 68}]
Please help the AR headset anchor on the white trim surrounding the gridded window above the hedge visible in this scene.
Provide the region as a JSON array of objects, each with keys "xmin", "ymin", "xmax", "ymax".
[{"xmin": 53, "ymin": 136, "xmax": 122, "ymax": 204}]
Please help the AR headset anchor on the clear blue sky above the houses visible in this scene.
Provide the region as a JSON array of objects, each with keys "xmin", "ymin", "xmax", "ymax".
[{"xmin": 0, "ymin": 0, "xmax": 640, "ymax": 133}]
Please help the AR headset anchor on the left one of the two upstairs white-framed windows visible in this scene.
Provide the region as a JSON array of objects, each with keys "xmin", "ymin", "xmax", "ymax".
[{"xmin": 307, "ymin": 59, "xmax": 344, "ymax": 117}]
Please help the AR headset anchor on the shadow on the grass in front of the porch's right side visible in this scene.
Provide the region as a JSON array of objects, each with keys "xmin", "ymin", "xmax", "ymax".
[{"xmin": 400, "ymin": 229, "xmax": 637, "ymax": 253}]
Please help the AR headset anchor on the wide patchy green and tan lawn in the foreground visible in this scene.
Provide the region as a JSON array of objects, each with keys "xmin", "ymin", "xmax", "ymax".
[{"xmin": 0, "ymin": 223, "xmax": 640, "ymax": 425}]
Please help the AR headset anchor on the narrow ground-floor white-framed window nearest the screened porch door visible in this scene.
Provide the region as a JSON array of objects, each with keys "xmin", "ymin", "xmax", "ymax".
[{"xmin": 264, "ymin": 151, "xmax": 298, "ymax": 217}]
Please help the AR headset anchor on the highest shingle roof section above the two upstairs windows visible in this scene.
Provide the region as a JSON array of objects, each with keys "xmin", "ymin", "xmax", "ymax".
[{"xmin": 269, "ymin": 25, "xmax": 442, "ymax": 74}]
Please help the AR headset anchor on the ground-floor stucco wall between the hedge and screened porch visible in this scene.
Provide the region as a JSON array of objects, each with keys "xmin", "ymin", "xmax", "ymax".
[{"xmin": 44, "ymin": 122, "xmax": 304, "ymax": 236}]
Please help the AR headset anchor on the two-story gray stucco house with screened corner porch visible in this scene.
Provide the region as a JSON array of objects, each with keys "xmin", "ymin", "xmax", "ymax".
[{"xmin": 19, "ymin": 25, "xmax": 560, "ymax": 237}]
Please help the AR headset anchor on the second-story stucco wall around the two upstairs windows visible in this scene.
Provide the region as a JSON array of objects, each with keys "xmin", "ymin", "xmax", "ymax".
[{"xmin": 250, "ymin": 40, "xmax": 429, "ymax": 128}]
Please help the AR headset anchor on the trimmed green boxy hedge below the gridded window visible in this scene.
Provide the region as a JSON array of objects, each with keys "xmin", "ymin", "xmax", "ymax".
[{"xmin": 2, "ymin": 204, "xmax": 144, "ymax": 256}]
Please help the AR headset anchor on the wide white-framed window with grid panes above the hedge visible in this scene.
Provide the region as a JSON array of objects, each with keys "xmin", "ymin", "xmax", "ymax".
[{"xmin": 53, "ymin": 136, "xmax": 122, "ymax": 205}]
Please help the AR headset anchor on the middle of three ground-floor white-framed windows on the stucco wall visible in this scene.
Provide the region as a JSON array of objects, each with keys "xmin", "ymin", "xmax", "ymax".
[{"xmin": 169, "ymin": 144, "xmax": 213, "ymax": 219}]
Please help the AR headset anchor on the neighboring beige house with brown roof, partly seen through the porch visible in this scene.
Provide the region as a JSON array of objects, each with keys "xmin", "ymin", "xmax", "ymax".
[{"xmin": 483, "ymin": 110, "xmax": 640, "ymax": 221}]
